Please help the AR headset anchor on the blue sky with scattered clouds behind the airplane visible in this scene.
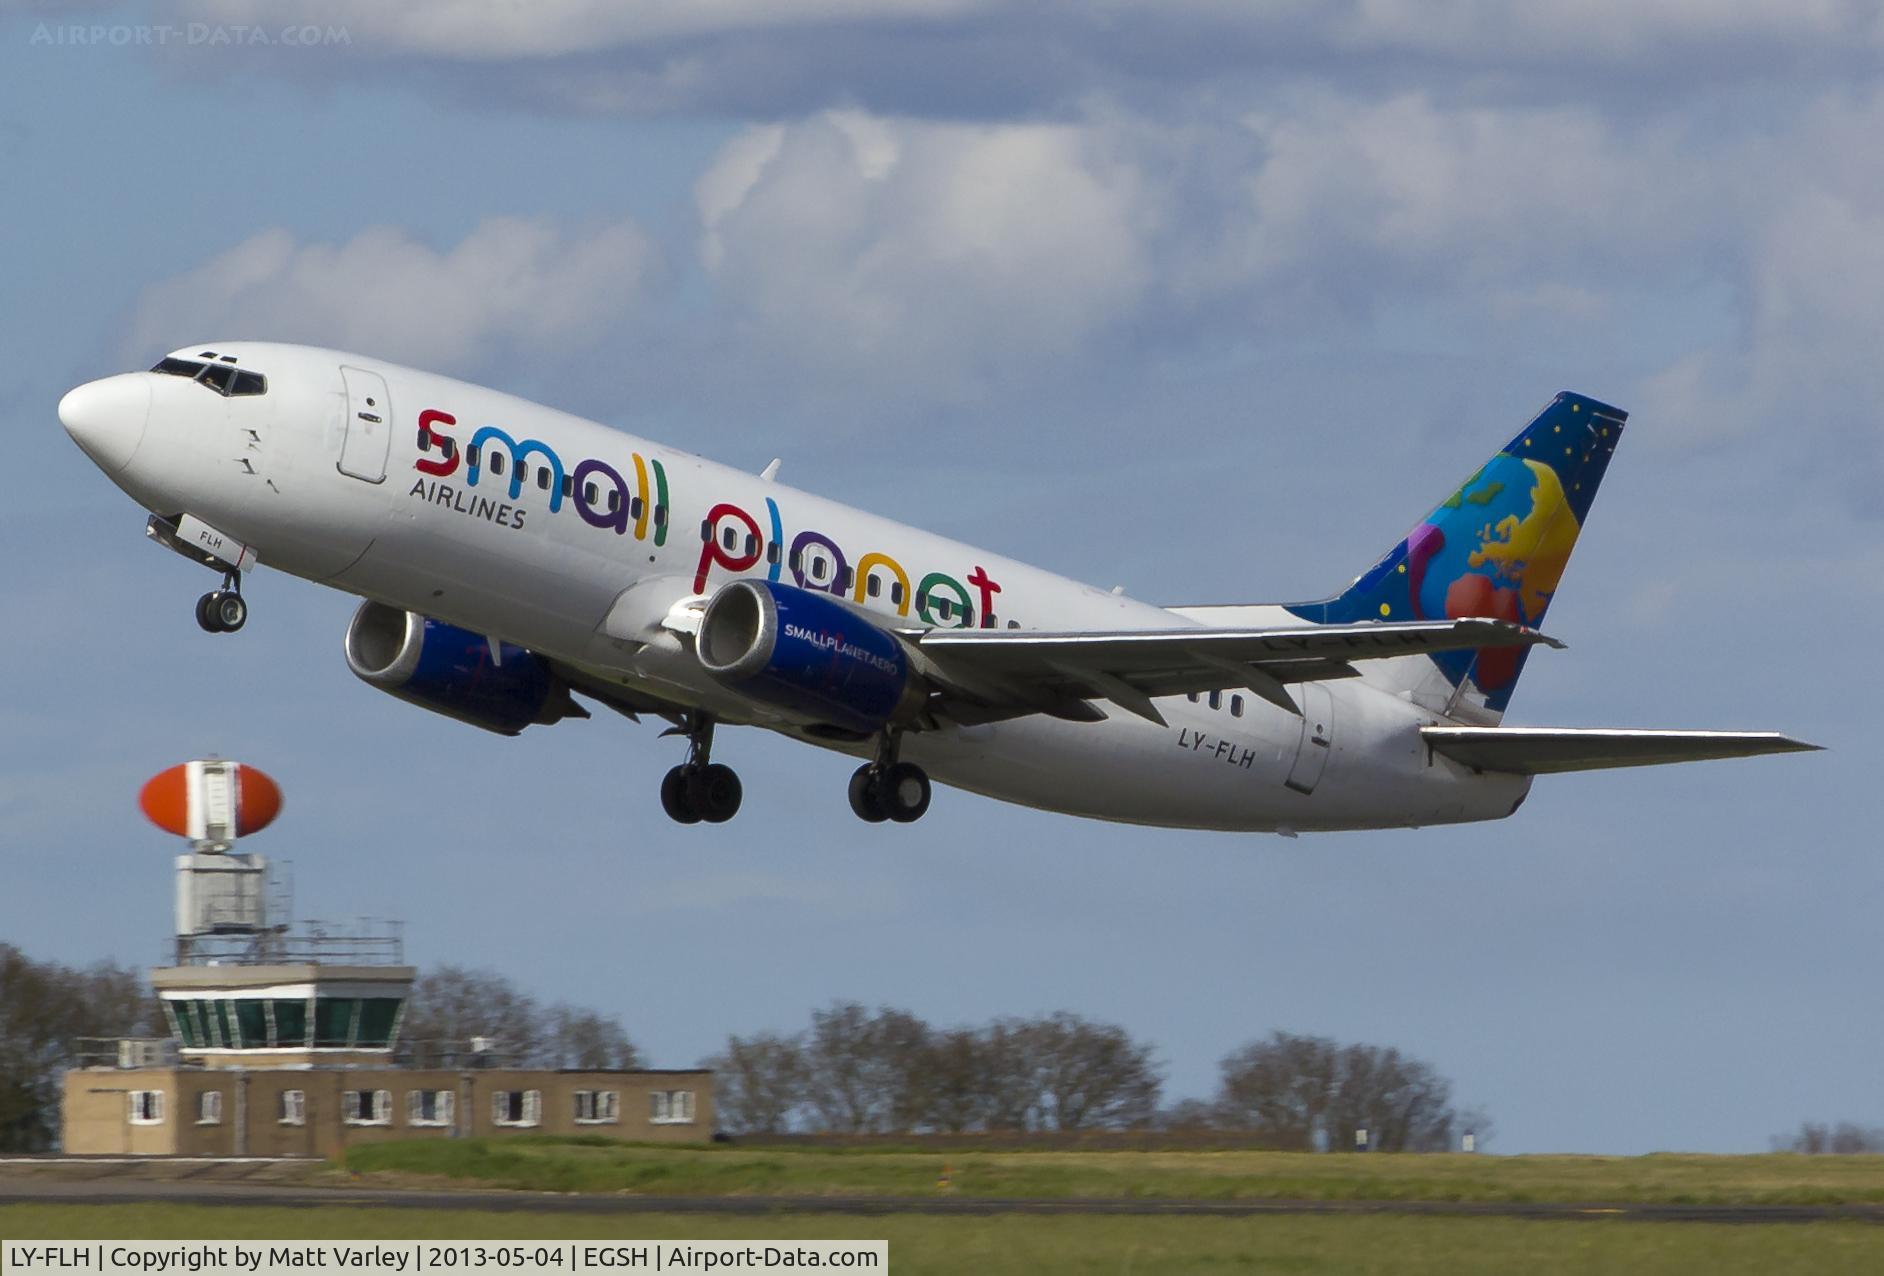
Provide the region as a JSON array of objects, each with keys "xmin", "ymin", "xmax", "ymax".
[{"xmin": 0, "ymin": 0, "xmax": 1884, "ymax": 1152}]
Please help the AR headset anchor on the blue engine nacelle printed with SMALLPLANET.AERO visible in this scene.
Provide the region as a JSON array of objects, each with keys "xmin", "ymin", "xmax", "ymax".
[{"xmin": 695, "ymin": 581, "xmax": 927, "ymax": 735}]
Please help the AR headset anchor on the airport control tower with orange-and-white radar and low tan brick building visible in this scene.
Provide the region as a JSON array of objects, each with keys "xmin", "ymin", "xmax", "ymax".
[{"xmin": 60, "ymin": 758, "xmax": 714, "ymax": 1157}]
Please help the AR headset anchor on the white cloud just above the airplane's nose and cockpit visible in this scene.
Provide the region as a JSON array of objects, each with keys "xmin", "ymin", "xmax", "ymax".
[{"xmin": 128, "ymin": 217, "xmax": 656, "ymax": 368}]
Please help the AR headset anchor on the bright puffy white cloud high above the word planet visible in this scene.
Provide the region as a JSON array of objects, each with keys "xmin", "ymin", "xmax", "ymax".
[{"xmin": 695, "ymin": 113, "xmax": 1157, "ymax": 381}]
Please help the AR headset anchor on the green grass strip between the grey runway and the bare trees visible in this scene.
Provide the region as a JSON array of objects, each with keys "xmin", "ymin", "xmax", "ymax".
[{"xmin": 345, "ymin": 1137, "xmax": 1884, "ymax": 1204}]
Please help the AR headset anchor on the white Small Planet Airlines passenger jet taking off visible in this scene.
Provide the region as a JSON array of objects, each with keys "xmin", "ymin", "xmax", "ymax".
[{"xmin": 58, "ymin": 341, "xmax": 1814, "ymax": 835}]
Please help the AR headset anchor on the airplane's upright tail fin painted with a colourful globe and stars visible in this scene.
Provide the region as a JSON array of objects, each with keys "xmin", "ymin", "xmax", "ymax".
[{"xmin": 1289, "ymin": 390, "xmax": 1628, "ymax": 722}]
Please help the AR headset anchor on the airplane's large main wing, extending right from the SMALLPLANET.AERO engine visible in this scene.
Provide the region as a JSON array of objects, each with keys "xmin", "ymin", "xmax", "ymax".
[{"xmin": 904, "ymin": 620, "xmax": 1562, "ymax": 726}]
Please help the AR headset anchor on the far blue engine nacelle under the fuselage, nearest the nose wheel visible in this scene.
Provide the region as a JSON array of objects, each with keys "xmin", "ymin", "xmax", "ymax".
[{"xmin": 347, "ymin": 603, "xmax": 588, "ymax": 735}]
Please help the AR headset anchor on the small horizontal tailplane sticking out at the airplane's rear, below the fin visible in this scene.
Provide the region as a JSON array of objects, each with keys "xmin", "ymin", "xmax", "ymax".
[{"xmin": 1421, "ymin": 728, "xmax": 1820, "ymax": 775}]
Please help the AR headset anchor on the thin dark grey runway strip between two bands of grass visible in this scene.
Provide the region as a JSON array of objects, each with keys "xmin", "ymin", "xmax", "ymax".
[{"xmin": 0, "ymin": 1176, "xmax": 1884, "ymax": 1223}]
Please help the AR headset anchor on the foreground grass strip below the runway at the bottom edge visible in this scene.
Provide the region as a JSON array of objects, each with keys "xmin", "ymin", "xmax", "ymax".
[{"xmin": 0, "ymin": 1204, "xmax": 1884, "ymax": 1276}]
